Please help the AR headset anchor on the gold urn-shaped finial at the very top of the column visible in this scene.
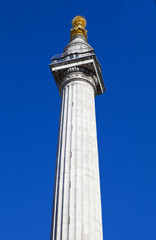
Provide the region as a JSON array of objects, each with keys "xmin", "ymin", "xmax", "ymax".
[{"xmin": 70, "ymin": 16, "xmax": 87, "ymax": 38}]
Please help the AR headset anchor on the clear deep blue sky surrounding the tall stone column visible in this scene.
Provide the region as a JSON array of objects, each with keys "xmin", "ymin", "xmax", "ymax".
[{"xmin": 0, "ymin": 0, "xmax": 156, "ymax": 240}]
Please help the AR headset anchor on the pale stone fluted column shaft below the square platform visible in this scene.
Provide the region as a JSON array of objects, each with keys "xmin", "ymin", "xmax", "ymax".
[{"xmin": 51, "ymin": 79, "xmax": 103, "ymax": 240}]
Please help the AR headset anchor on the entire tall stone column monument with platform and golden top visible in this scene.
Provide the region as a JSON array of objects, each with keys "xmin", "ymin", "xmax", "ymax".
[{"xmin": 50, "ymin": 16, "xmax": 105, "ymax": 240}]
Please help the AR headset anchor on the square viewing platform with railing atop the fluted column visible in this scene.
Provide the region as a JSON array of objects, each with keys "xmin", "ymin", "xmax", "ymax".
[{"xmin": 49, "ymin": 50, "xmax": 106, "ymax": 95}]
